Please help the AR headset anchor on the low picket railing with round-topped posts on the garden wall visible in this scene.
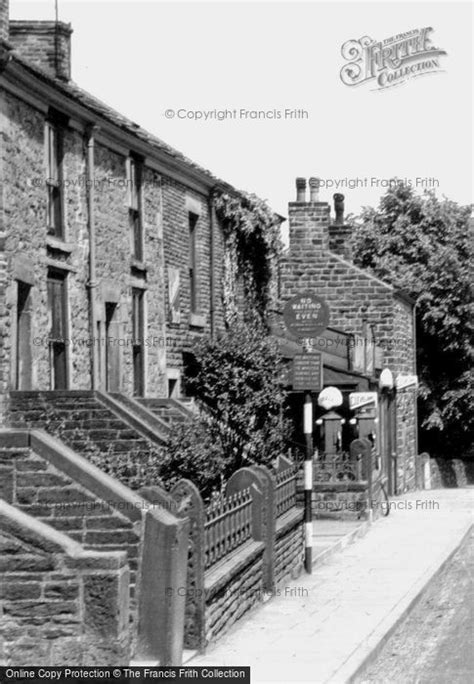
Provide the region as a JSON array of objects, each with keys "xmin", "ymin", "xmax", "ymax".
[{"xmin": 163, "ymin": 456, "xmax": 302, "ymax": 649}]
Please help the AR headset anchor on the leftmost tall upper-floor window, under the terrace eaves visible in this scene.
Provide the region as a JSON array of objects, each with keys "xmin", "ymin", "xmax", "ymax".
[{"xmin": 46, "ymin": 121, "xmax": 64, "ymax": 238}]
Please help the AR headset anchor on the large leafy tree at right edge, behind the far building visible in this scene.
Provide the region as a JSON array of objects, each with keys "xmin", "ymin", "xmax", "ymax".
[{"xmin": 353, "ymin": 184, "xmax": 474, "ymax": 457}]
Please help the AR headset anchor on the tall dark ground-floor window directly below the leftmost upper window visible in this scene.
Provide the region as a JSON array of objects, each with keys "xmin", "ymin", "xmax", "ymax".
[{"xmin": 47, "ymin": 272, "xmax": 68, "ymax": 390}]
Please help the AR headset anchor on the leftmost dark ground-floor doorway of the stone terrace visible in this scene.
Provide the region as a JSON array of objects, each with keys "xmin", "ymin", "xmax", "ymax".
[{"xmin": 15, "ymin": 281, "xmax": 33, "ymax": 390}]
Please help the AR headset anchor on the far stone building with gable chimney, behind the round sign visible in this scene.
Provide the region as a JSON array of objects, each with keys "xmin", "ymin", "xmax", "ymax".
[{"xmin": 280, "ymin": 178, "xmax": 417, "ymax": 492}]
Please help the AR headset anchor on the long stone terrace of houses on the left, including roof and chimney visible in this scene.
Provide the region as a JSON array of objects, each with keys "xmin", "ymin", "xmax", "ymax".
[{"xmin": 0, "ymin": 3, "xmax": 260, "ymax": 412}]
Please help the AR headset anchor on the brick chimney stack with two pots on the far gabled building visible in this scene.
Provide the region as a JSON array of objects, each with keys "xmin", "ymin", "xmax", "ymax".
[{"xmin": 288, "ymin": 178, "xmax": 330, "ymax": 258}]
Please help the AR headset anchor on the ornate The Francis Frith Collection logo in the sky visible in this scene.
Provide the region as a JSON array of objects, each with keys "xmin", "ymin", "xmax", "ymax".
[{"xmin": 340, "ymin": 27, "xmax": 446, "ymax": 90}]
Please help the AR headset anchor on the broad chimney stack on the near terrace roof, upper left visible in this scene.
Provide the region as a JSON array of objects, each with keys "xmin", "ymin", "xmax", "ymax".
[{"xmin": 9, "ymin": 20, "xmax": 72, "ymax": 81}]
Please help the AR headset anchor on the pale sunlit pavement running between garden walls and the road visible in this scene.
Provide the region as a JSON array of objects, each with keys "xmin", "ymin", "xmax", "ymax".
[{"xmin": 186, "ymin": 488, "xmax": 474, "ymax": 684}]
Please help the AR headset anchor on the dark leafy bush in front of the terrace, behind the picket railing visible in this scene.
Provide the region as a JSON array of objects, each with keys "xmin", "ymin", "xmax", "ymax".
[{"xmin": 162, "ymin": 321, "xmax": 288, "ymax": 492}]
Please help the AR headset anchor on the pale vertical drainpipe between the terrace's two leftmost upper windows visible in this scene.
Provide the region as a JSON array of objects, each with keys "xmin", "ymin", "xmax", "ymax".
[{"xmin": 85, "ymin": 124, "xmax": 100, "ymax": 390}]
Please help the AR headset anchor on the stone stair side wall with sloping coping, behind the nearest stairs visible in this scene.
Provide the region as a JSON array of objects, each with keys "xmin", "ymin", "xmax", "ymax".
[{"xmin": 9, "ymin": 390, "xmax": 169, "ymax": 486}]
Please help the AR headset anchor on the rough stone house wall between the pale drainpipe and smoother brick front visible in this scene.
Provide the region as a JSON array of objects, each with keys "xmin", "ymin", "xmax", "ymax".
[{"xmin": 95, "ymin": 144, "xmax": 165, "ymax": 396}]
